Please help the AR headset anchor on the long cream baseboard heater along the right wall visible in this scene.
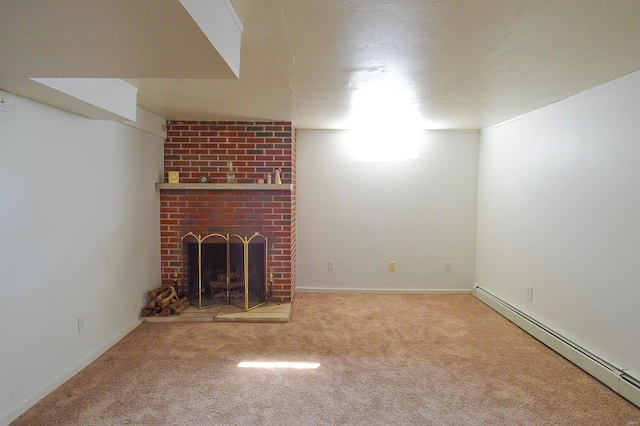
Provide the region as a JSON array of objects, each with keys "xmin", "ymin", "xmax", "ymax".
[{"xmin": 473, "ymin": 285, "xmax": 640, "ymax": 407}]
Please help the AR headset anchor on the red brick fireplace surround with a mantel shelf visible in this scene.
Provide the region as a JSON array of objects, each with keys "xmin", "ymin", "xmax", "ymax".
[{"xmin": 160, "ymin": 121, "xmax": 296, "ymax": 303}]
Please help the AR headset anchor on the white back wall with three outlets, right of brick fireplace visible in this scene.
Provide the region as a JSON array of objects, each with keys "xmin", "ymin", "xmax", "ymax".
[{"xmin": 297, "ymin": 130, "xmax": 478, "ymax": 291}]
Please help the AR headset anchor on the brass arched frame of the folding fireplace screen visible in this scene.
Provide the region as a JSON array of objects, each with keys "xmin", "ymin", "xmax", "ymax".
[{"xmin": 181, "ymin": 232, "xmax": 268, "ymax": 311}]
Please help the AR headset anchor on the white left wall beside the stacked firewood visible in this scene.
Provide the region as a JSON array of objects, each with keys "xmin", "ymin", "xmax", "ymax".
[{"xmin": 0, "ymin": 97, "xmax": 163, "ymax": 424}]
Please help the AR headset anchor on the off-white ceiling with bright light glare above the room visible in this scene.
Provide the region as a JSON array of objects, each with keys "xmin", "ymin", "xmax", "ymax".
[{"xmin": 0, "ymin": 0, "xmax": 640, "ymax": 129}]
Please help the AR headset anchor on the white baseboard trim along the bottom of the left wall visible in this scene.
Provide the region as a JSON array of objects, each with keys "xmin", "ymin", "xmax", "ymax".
[{"xmin": 0, "ymin": 319, "xmax": 142, "ymax": 426}]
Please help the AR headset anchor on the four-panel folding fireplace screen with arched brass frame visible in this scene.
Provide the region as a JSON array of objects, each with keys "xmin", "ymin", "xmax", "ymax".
[{"xmin": 182, "ymin": 232, "xmax": 267, "ymax": 311}]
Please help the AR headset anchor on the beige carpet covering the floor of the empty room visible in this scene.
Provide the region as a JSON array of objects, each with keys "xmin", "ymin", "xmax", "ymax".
[{"xmin": 14, "ymin": 293, "xmax": 640, "ymax": 426}]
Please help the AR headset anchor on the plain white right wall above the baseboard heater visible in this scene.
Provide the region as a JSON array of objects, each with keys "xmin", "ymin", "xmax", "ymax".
[{"xmin": 477, "ymin": 73, "xmax": 640, "ymax": 377}]
